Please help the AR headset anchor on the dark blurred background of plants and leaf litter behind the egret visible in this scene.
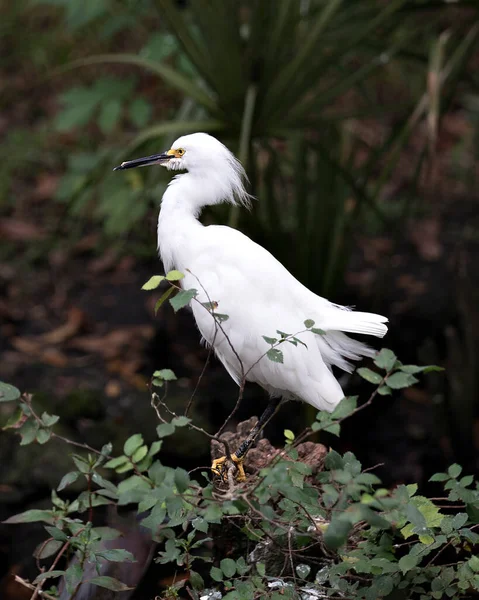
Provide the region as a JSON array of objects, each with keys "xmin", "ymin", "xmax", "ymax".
[{"xmin": 0, "ymin": 0, "xmax": 479, "ymax": 598}]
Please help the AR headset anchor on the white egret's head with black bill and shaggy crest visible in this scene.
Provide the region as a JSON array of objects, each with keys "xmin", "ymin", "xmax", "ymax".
[{"xmin": 113, "ymin": 133, "xmax": 250, "ymax": 206}]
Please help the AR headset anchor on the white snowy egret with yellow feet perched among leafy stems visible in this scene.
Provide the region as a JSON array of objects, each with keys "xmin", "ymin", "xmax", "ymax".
[{"xmin": 114, "ymin": 133, "xmax": 387, "ymax": 480}]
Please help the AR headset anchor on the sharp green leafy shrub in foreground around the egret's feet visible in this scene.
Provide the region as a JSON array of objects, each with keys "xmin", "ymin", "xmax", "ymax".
[{"xmin": 0, "ymin": 278, "xmax": 479, "ymax": 600}]
